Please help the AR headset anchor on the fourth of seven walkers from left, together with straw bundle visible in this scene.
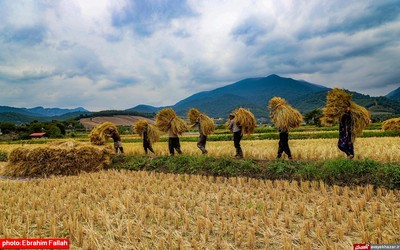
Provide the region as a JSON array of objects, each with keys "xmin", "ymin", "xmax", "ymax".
[{"xmin": 188, "ymin": 108, "xmax": 215, "ymax": 154}]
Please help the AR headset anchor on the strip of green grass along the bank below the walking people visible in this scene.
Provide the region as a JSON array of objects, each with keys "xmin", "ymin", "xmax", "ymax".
[{"xmin": 113, "ymin": 155, "xmax": 400, "ymax": 189}]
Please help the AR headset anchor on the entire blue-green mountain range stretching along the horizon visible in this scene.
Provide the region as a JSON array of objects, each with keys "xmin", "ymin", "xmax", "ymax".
[{"xmin": 0, "ymin": 75, "xmax": 400, "ymax": 122}]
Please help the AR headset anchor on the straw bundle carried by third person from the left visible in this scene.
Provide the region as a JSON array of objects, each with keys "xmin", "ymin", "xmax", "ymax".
[{"xmin": 155, "ymin": 108, "xmax": 188, "ymax": 135}]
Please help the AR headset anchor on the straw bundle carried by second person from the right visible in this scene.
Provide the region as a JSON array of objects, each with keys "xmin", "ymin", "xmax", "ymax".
[{"xmin": 268, "ymin": 97, "xmax": 303, "ymax": 131}]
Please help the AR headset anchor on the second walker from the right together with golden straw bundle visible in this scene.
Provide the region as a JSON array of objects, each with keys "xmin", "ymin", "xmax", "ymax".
[{"xmin": 268, "ymin": 97, "xmax": 303, "ymax": 160}]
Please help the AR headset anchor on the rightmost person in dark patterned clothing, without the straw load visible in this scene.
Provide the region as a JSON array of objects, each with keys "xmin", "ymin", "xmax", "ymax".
[{"xmin": 338, "ymin": 109, "xmax": 354, "ymax": 159}]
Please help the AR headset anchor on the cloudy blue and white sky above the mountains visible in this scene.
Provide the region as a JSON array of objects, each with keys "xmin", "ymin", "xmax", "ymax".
[{"xmin": 0, "ymin": 0, "xmax": 400, "ymax": 111}]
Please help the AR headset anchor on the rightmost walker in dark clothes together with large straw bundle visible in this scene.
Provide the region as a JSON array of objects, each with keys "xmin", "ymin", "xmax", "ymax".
[{"xmin": 321, "ymin": 88, "xmax": 371, "ymax": 159}]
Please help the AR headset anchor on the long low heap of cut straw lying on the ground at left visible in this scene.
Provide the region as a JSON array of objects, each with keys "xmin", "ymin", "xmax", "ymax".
[{"xmin": 2, "ymin": 141, "xmax": 114, "ymax": 177}]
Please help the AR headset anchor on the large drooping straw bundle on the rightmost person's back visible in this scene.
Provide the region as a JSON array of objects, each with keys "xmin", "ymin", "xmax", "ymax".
[{"xmin": 321, "ymin": 88, "xmax": 371, "ymax": 140}]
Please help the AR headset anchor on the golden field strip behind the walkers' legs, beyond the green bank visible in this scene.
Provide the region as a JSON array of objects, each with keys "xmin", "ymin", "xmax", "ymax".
[{"xmin": 0, "ymin": 137, "xmax": 400, "ymax": 162}]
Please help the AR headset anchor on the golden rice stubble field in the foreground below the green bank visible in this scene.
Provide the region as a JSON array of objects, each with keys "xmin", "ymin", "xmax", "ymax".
[{"xmin": 0, "ymin": 171, "xmax": 400, "ymax": 249}]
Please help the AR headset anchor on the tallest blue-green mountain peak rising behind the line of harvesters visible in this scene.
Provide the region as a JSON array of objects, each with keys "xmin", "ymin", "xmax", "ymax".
[{"xmin": 132, "ymin": 75, "xmax": 329, "ymax": 117}]
